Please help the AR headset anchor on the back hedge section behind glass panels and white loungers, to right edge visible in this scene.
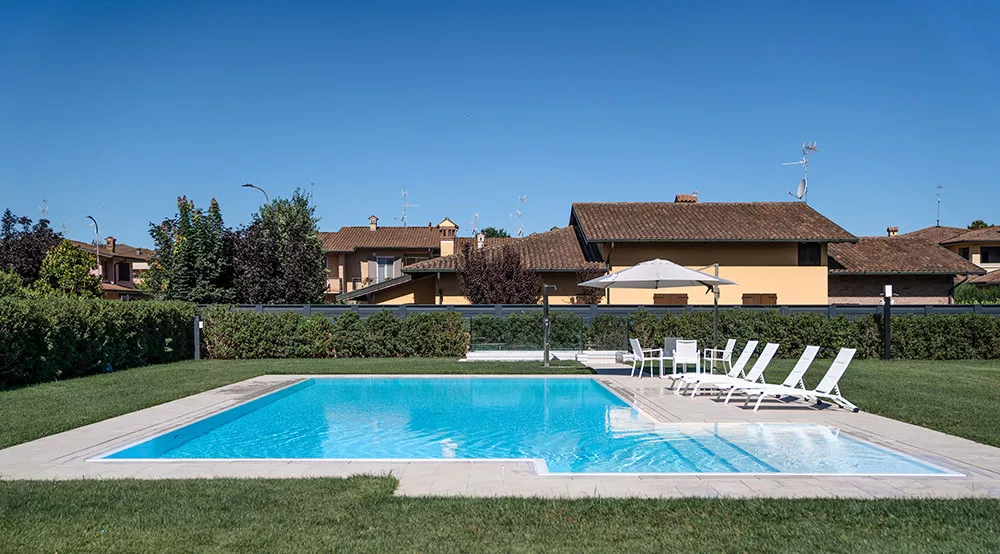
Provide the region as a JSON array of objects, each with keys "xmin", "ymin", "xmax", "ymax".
[{"xmin": 470, "ymin": 310, "xmax": 1000, "ymax": 360}]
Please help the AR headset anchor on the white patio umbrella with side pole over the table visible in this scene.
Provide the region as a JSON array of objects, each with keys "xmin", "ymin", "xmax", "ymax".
[{"xmin": 579, "ymin": 259, "xmax": 738, "ymax": 347}]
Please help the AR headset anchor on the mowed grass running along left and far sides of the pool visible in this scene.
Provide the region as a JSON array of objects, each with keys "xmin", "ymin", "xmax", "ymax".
[{"xmin": 0, "ymin": 358, "xmax": 592, "ymax": 448}]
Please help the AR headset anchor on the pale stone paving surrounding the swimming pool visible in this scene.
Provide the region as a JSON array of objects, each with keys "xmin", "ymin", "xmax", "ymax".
[{"xmin": 0, "ymin": 368, "xmax": 1000, "ymax": 498}]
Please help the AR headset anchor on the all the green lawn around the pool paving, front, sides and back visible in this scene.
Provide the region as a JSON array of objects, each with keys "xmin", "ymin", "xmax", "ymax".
[{"xmin": 0, "ymin": 359, "xmax": 1000, "ymax": 554}]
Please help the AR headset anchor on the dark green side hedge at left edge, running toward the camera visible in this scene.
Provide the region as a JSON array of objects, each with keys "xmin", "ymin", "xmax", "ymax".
[{"xmin": 0, "ymin": 296, "xmax": 194, "ymax": 387}]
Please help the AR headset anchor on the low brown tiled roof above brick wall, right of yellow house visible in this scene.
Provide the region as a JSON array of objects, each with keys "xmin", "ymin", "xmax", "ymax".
[{"xmin": 829, "ymin": 236, "xmax": 983, "ymax": 275}]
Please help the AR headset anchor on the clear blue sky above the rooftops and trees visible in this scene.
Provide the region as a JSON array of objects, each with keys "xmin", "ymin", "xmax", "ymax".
[{"xmin": 0, "ymin": 0, "xmax": 1000, "ymax": 245}]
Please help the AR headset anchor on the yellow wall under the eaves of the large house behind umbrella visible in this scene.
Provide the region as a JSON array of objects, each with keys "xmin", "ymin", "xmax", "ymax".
[{"xmin": 602, "ymin": 243, "xmax": 829, "ymax": 305}]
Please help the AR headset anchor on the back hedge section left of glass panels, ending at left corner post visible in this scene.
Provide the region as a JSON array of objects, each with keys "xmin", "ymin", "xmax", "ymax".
[{"xmin": 201, "ymin": 306, "xmax": 469, "ymax": 360}]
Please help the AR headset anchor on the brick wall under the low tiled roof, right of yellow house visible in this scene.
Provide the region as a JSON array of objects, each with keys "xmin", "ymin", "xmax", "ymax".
[{"xmin": 830, "ymin": 275, "xmax": 955, "ymax": 305}]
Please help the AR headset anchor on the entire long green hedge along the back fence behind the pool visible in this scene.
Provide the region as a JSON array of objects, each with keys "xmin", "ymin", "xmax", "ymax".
[{"xmin": 195, "ymin": 308, "xmax": 1000, "ymax": 360}]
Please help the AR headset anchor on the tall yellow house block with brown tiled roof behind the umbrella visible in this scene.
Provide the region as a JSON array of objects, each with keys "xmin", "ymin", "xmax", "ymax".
[{"xmin": 570, "ymin": 195, "xmax": 857, "ymax": 305}]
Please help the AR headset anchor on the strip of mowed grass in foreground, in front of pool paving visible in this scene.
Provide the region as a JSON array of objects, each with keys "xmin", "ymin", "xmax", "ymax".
[{"xmin": 0, "ymin": 477, "xmax": 1000, "ymax": 554}]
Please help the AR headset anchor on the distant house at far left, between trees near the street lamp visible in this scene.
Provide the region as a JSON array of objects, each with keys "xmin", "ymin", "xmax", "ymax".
[{"xmin": 70, "ymin": 237, "xmax": 152, "ymax": 300}]
